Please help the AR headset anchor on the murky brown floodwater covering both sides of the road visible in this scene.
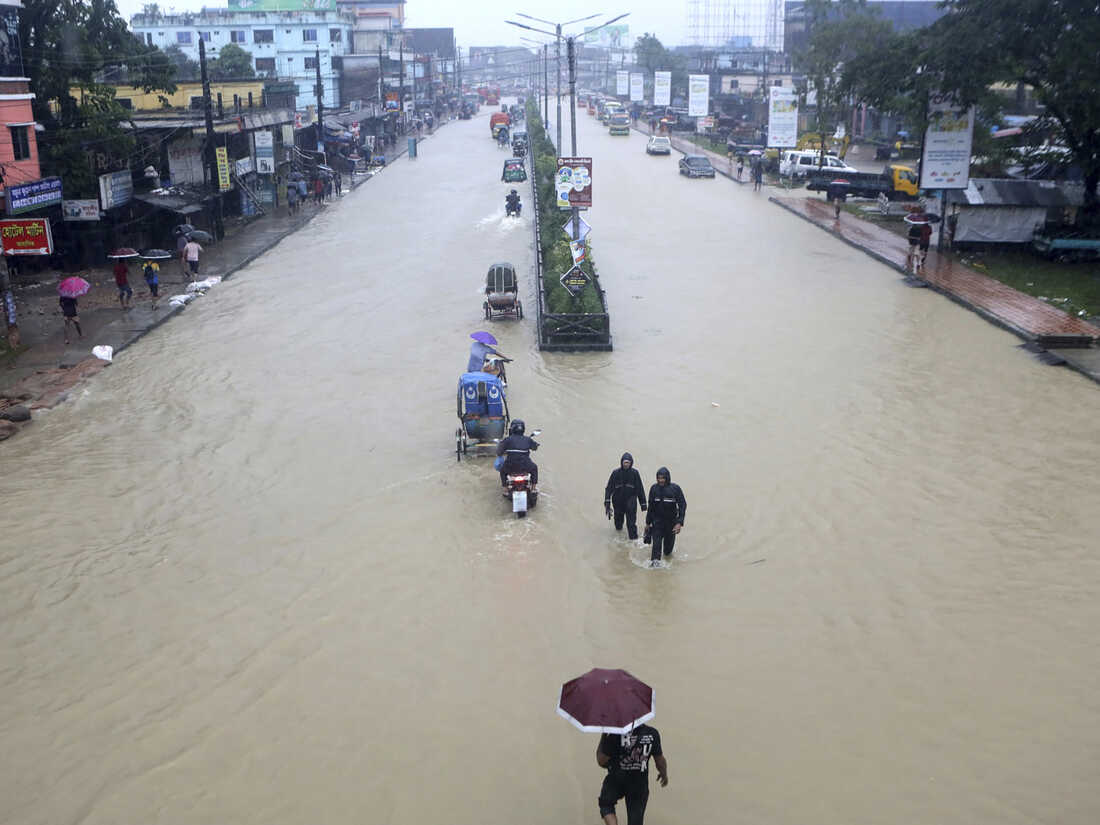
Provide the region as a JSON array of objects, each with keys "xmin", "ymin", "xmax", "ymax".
[{"xmin": 0, "ymin": 103, "xmax": 1100, "ymax": 825}]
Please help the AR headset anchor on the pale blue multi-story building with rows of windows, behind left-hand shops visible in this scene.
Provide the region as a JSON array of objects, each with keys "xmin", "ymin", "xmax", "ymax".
[{"xmin": 130, "ymin": 0, "xmax": 354, "ymax": 108}]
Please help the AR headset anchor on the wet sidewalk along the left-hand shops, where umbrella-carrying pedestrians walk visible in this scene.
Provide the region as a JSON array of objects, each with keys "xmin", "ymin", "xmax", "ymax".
[{"xmin": 0, "ymin": 129, "xmax": 420, "ymax": 440}]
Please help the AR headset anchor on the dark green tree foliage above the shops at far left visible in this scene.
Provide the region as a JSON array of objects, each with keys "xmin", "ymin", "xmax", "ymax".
[{"xmin": 19, "ymin": 0, "xmax": 176, "ymax": 197}]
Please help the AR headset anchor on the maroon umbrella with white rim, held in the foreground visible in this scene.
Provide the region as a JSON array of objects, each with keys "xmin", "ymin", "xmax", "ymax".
[{"xmin": 558, "ymin": 668, "xmax": 656, "ymax": 734}]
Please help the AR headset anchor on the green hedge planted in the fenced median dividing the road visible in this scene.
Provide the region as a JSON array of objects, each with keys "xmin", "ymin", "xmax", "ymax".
[{"xmin": 527, "ymin": 100, "xmax": 604, "ymax": 312}]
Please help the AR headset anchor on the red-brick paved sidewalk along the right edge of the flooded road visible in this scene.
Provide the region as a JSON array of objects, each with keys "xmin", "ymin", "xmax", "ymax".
[{"xmin": 769, "ymin": 197, "xmax": 1100, "ymax": 356}]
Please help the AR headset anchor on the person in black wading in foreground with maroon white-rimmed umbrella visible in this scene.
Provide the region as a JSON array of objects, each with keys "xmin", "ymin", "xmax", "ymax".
[{"xmin": 558, "ymin": 668, "xmax": 669, "ymax": 825}]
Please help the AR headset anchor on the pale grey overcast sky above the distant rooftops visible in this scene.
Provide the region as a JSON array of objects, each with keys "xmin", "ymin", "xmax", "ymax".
[{"xmin": 118, "ymin": 0, "xmax": 688, "ymax": 48}]
